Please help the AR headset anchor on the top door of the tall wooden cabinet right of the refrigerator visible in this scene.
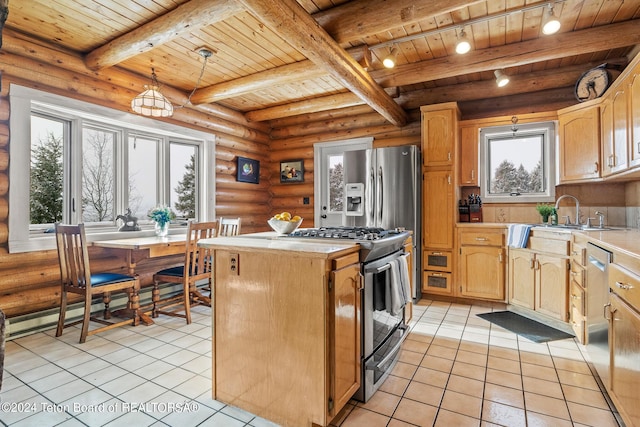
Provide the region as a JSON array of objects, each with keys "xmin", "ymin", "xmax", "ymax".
[{"xmin": 422, "ymin": 109, "xmax": 458, "ymax": 166}]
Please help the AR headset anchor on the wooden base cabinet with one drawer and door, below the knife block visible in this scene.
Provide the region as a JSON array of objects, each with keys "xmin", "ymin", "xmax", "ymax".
[{"xmin": 457, "ymin": 227, "xmax": 506, "ymax": 301}]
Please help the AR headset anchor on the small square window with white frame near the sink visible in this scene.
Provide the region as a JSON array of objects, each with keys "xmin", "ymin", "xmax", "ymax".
[{"xmin": 480, "ymin": 122, "xmax": 555, "ymax": 203}]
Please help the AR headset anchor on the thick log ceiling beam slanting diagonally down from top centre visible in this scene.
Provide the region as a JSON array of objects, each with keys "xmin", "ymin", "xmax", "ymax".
[{"xmin": 240, "ymin": 0, "xmax": 408, "ymax": 126}]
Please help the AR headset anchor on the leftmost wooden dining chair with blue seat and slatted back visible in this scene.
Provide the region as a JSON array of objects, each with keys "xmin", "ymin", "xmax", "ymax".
[{"xmin": 55, "ymin": 224, "xmax": 140, "ymax": 343}]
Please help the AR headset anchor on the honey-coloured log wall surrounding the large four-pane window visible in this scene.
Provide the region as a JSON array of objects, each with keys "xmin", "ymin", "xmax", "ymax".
[{"xmin": 0, "ymin": 34, "xmax": 272, "ymax": 318}]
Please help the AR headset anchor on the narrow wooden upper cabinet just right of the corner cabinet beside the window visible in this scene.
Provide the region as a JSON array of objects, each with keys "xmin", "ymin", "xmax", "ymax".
[{"xmin": 600, "ymin": 85, "xmax": 629, "ymax": 176}]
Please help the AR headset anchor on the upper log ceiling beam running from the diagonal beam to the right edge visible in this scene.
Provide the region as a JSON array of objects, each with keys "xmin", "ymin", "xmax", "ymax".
[{"xmin": 371, "ymin": 19, "xmax": 640, "ymax": 87}]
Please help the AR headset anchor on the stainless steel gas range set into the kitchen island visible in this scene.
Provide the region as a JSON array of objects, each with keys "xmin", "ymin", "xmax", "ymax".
[{"xmin": 288, "ymin": 227, "xmax": 411, "ymax": 402}]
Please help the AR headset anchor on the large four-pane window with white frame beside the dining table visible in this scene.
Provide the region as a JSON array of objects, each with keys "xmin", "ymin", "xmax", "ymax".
[{"xmin": 9, "ymin": 85, "xmax": 215, "ymax": 252}]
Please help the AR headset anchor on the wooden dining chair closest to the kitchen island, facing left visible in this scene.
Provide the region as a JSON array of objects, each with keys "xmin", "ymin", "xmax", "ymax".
[{"xmin": 152, "ymin": 221, "xmax": 218, "ymax": 324}]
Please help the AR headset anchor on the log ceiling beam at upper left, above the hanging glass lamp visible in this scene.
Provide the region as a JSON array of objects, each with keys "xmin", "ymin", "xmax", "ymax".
[{"xmin": 85, "ymin": 0, "xmax": 244, "ymax": 70}]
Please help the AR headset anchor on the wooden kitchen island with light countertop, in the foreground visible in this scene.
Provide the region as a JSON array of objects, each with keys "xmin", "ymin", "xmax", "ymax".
[{"xmin": 199, "ymin": 233, "xmax": 361, "ymax": 427}]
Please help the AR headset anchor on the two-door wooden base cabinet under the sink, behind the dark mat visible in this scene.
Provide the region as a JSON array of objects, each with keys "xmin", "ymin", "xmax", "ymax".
[{"xmin": 509, "ymin": 230, "xmax": 571, "ymax": 322}]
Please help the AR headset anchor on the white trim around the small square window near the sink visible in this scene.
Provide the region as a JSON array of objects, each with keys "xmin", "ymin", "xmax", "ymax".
[{"xmin": 478, "ymin": 121, "xmax": 558, "ymax": 203}]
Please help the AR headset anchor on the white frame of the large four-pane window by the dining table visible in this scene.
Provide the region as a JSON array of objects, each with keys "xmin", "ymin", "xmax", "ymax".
[{"xmin": 9, "ymin": 84, "xmax": 215, "ymax": 253}]
